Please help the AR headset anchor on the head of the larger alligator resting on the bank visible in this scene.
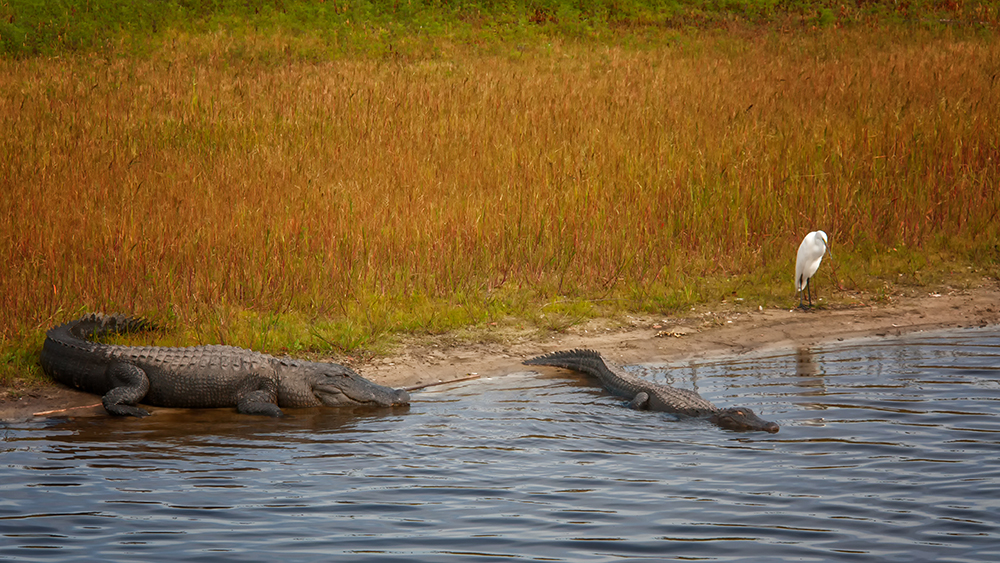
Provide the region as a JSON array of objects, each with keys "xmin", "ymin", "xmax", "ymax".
[{"xmin": 297, "ymin": 362, "xmax": 410, "ymax": 407}]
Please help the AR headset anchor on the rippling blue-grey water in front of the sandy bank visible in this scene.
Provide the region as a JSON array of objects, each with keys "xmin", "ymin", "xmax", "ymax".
[{"xmin": 0, "ymin": 328, "xmax": 1000, "ymax": 563}]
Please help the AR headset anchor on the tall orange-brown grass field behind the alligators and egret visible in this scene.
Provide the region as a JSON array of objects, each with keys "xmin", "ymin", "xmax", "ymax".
[{"xmin": 0, "ymin": 2, "xmax": 1000, "ymax": 384}]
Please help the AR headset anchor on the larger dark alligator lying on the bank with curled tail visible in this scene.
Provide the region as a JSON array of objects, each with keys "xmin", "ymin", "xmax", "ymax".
[{"xmin": 41, "ymin": 313, "xmax": 410, "ymax": 416}]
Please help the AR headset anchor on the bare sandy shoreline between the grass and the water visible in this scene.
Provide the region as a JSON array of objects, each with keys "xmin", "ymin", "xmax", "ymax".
[{"xmin": 0, "ymin": 283, "xmax": 1000, "ymax": 421}]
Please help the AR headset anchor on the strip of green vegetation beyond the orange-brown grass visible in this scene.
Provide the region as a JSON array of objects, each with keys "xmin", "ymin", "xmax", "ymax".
[{"xmin": 0, "ymin": 0, "xmax": 1000, "ymax": 58}]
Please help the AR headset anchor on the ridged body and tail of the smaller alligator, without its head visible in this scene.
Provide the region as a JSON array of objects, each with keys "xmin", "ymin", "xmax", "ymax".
[{"xmin": 524, "ymin": 350, "xmax": 719, "ymax": 416}]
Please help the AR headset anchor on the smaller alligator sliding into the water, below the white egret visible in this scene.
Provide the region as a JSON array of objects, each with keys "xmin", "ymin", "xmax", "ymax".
[{"xmin": 524, "ymin": 350, "xmax": 778, "ymax": 432}]
